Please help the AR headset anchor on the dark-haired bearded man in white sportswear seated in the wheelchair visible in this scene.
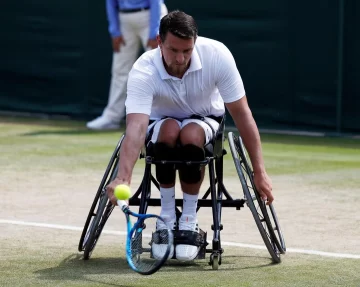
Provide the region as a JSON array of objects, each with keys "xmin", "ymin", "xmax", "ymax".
[{"xmin": 107, "ymin": 11, "xmax": 274, "ymax": 261}]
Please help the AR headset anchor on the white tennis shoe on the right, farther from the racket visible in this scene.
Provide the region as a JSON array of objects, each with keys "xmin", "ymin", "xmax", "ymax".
[{"xmin": 176, "ymin": 215, "xmax": 200, "ymax": 261}]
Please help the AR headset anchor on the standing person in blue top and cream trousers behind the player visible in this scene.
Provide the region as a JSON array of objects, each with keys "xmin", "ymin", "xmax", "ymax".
[{"xmin": 86, "ymin": 0, "xmax": 167, "ymax": 130}]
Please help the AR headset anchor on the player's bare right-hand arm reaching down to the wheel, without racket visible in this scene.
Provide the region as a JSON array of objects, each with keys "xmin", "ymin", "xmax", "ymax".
[{"xmin": 225, "ymin": 96, "xmax": 274, "ymax": 204}]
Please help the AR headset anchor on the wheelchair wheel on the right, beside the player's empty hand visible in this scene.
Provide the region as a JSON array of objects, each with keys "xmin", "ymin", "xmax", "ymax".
[{"xmin": 228, "ymin": 132, "xmax": 286, "ymax": 263}]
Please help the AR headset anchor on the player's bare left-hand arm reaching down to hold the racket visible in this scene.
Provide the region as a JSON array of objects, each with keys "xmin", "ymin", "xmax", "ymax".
[{"xmin": 106, "ymin": 114, "xmax": 149, "ymax": 204}]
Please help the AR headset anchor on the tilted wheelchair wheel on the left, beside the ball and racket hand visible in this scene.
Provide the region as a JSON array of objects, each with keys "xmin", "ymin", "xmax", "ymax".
[{"xmin": 78, "ymin": 135, "xmax": 124, "ymax": 260}]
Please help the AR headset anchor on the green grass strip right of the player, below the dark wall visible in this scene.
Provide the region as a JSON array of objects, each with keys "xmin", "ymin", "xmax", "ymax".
[{"xmin": 262, "ymin": 135, "xmax": 360, "ymax": 174}]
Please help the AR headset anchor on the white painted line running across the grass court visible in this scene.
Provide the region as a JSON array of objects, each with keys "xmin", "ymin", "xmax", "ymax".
[{"xmin": 0, "ymin": 219, "xmax": 360, "ymax": 259}]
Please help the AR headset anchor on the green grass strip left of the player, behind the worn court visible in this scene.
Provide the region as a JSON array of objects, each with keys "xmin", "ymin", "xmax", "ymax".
[{"xmin": 0, "ymin": 118, "xmax": 122, "ymax": 171}]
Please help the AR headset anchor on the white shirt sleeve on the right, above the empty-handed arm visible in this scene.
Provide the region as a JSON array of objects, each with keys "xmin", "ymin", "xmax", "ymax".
[{"xmin": 214, "ymin": 44, "xmax": 245, "ymax": 103}]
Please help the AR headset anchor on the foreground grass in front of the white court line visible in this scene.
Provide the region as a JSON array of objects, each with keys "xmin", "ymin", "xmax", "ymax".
[{"xmin": 0, "ymin": 230, "xmax": 360, "ymax": 287}]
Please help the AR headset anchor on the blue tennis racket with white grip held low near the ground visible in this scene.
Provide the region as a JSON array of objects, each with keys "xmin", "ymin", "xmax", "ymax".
[{"xmin": 117, "ymin": 200, "xmax": 174, "ymax": 275}]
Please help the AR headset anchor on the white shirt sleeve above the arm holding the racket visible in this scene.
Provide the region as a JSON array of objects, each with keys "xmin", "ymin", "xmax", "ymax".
[{"xmin": 125, "ymin": 68, "xmax": 155, "ymax": 116}]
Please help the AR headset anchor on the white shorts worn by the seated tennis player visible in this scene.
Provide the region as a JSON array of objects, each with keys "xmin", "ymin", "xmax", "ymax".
[{"xmin": 148, "ymin": 117, "xmax": 219, "ymax": 145}]
